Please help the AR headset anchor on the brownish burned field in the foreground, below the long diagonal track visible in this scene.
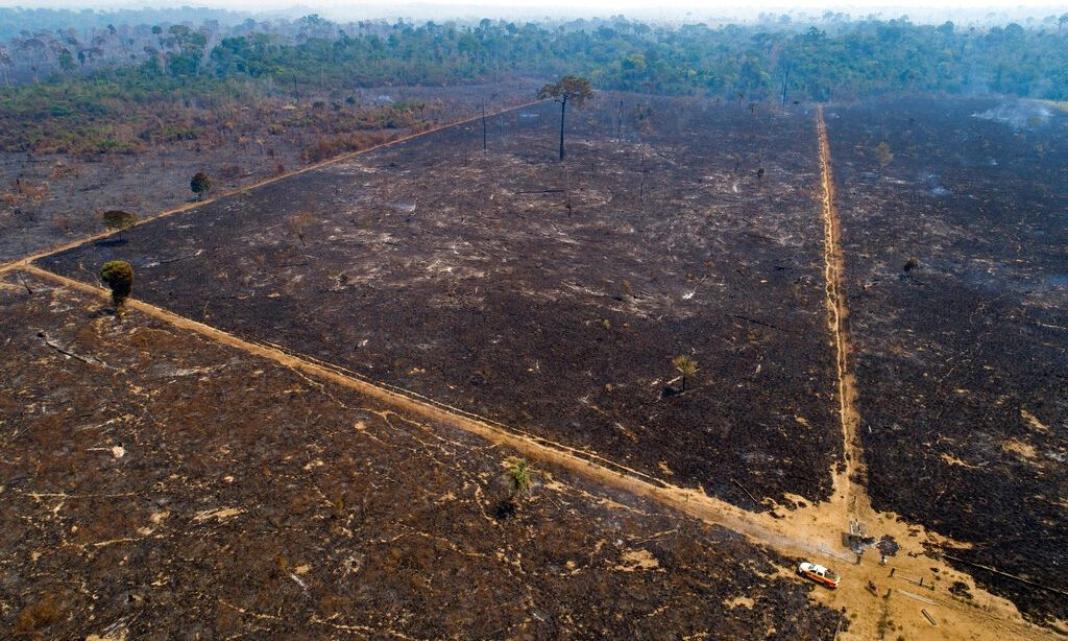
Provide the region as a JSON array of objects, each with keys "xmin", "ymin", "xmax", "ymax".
[{"xmin": 0, "ymin": 280, "xmax": 838, "ymax": 639}]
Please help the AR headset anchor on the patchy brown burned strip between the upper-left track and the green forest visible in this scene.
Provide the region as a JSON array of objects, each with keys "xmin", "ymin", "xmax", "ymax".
[{"xmin": 0, "ymin": 80, "xmax": 535, "ymax": 262}]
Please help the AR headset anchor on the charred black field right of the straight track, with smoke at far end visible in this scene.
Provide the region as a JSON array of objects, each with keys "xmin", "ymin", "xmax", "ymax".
[{"xmin": 828, "ymin": 100, "xmax": 1068, "ymax": 621}]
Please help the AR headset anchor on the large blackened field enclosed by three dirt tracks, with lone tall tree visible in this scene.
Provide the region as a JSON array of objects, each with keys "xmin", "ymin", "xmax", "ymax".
[{"xmin": 35, "ymin": 95, "xmax": 842, "ymax": 509}]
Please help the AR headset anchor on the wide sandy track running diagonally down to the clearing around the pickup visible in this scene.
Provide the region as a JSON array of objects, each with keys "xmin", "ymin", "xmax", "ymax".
[{"xmin": 16, "ymin": 224, "xmax": 1052, "ymax": 640}]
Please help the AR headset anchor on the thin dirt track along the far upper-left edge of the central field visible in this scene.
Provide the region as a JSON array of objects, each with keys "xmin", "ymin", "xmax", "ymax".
[{"xmin": 0, "ymin": 100, "xmax": 544, "ymax": 275}]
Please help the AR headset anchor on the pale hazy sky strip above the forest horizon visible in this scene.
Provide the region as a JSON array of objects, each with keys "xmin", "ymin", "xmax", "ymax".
[{"xmin": 0, "ymin": 0, "xmax": 1068, "ymax": 20}]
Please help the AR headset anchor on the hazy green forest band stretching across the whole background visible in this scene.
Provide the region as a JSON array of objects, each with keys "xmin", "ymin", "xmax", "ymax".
[{"xmin": 0, "ymin": 14, "xmax": 1068, "ymax": 153}]
